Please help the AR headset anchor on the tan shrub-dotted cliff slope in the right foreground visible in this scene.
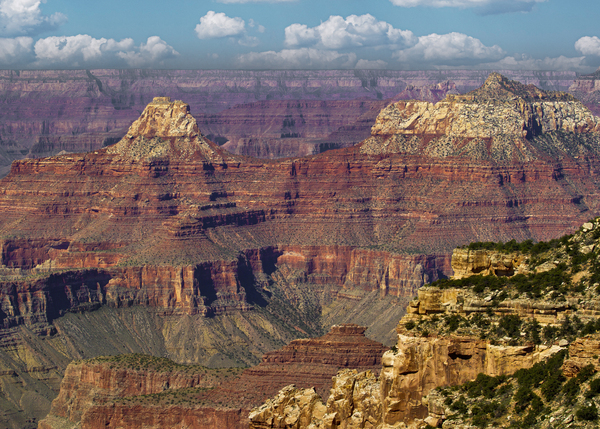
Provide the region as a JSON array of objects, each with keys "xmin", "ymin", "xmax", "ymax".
[{"xmin": 250, "ymin": 218, "xmax": 600, "ymax": 429}]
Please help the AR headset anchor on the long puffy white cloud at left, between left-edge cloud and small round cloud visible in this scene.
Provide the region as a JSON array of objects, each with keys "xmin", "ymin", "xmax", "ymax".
[{"xmin": 34, "ymin": 34, "xmax": 178, "ymax": 67}]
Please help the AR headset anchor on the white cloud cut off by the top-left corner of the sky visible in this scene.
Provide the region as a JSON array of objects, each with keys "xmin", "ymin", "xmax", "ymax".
[{"xmin": 0, "ymin": 0, "xmax": 67, "ymax": 36}]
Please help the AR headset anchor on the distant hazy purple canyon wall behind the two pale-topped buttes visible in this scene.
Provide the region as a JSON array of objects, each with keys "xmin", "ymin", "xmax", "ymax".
[{"xmin": 0, "ymin": 70, "xmax": 580, "ymax": 175}]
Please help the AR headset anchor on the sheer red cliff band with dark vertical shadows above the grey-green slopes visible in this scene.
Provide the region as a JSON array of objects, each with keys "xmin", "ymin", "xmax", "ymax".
[{"xmin": 0, "ymin": 241, "xmax": 451, "ymax": 328}]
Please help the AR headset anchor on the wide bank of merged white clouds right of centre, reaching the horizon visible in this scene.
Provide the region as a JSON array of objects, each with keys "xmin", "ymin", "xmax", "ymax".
[{"xmin": 238, "ymin": 14, "xmax": 506, "ymax": 69}]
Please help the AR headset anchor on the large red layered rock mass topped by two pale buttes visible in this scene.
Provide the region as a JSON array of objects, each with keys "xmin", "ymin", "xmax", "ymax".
[{"xmin": 0, "ymin": 74, "xmax": 600, "ymax": 427}]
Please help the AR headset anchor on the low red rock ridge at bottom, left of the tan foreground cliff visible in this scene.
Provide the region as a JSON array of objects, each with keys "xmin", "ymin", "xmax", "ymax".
[{"xmin": 39, "ymin": 324, "xmax": 387, "ymax": 429}]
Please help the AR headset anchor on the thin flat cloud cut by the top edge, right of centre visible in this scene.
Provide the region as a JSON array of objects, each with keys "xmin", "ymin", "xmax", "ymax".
[{"xmin": 390, "ymin": 0, "xmax": 547, "ymax": 14}]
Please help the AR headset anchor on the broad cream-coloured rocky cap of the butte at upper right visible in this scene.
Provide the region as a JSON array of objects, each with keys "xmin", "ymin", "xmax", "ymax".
[{"xmin": 362, "ymin": 73, "xmax": 600, "ymax": 162}]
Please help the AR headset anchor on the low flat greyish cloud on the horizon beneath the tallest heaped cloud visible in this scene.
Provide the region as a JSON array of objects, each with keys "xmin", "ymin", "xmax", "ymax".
[{"xmin": 238, "ymin": 48, "xmax": 356, "ymax": 69}]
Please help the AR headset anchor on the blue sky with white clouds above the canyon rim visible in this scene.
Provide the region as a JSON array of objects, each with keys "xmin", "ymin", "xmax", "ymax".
[{"xmin": 0, "ymin": 0, "xmax": 600, "ymax": 73}]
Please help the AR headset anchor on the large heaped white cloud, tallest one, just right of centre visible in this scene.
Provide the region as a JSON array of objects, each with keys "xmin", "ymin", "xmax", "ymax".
[{"xmin": 285, "ymin": 14, "xmax": 416, "ymax": 49}]
